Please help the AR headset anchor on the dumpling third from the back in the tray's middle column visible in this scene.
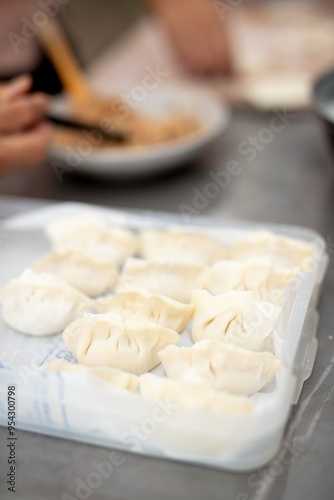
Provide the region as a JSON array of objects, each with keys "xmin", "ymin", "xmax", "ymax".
[{"xmin": 95, "ymin": 285, "xmax": 194, "ymax": 333}]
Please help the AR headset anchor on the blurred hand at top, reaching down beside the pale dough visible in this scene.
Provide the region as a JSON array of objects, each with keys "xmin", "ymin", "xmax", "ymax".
[{"xmin": 148, "ymin": 0, "xmax": 230, "ymax": 74}]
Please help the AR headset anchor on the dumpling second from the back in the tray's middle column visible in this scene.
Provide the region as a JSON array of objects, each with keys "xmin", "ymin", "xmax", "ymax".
[{"xmin": 120, "ymin": 258, "xmax": 206, "ymax": 304}]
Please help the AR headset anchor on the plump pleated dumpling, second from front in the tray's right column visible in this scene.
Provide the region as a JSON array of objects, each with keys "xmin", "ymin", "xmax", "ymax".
[{"xmin": 159, "ymin": 340, "xmax": 278, "ymax": 396}]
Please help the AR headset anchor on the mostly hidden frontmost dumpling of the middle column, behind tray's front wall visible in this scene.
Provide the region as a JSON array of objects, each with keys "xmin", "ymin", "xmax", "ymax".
[{"xmin": 45, "ymin": 359, "xmax": 139, "ymax": 391}]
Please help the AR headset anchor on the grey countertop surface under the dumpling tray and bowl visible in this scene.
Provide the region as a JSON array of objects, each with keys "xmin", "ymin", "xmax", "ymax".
[{"xmin": 0, "ymin": 111, "xmax": 334, "ymax": 500}]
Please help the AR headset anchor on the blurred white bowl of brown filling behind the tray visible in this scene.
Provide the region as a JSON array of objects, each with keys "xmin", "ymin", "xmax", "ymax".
[{"xmin": 50, "ymin": 85, "xmax": 231, "ymax": 178}]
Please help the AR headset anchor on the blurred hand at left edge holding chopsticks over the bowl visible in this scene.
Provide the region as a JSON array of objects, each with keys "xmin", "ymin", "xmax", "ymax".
[{"xmin": 0, "ymin": 75, "xmax": 50, "ymax": 173}]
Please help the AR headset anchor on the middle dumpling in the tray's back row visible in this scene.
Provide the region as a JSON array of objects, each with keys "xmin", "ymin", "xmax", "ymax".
[{"xmin": 140, "ymin": 230, "xmax": 227, "ymax": 266}]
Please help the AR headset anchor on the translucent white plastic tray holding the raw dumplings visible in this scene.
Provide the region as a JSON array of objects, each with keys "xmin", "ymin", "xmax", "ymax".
[{"xmin": 0, "ymin": 203, "xmax": 328, "ymax": 471}]
